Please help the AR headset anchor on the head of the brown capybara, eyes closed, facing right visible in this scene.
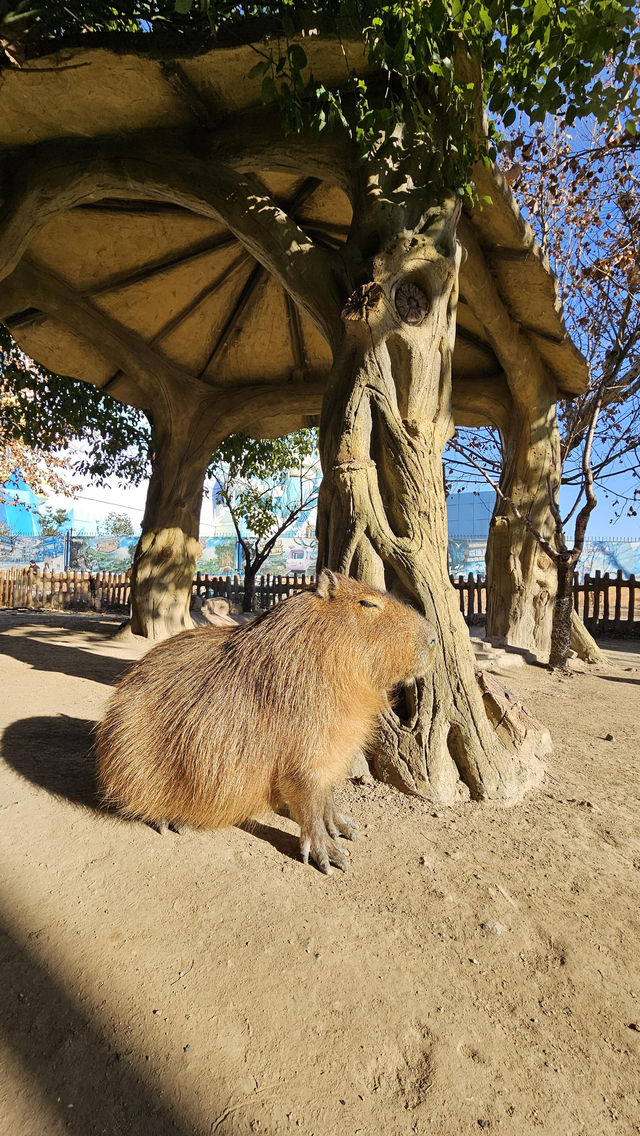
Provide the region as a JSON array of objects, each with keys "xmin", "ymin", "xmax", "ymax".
[{"xmin": 315, "ymin": 568, "xmax": 438, "ymax": 690}]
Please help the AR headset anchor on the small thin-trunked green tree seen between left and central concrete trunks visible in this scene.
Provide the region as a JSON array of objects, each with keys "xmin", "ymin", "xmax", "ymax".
[{"xmin": 209, "ymin": 429, "xmax": 319, "ymax": 611}]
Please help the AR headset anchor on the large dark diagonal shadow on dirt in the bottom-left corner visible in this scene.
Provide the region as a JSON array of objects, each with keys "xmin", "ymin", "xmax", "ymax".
[{"xmin": 0, "ymin": 920, "xmax": 230, "ymax": 1136}]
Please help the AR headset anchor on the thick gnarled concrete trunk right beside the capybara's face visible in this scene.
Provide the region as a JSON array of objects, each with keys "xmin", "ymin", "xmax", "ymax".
[{"xmin": 318, "ymin": 198, "xmax": 547, "ymax": 802}]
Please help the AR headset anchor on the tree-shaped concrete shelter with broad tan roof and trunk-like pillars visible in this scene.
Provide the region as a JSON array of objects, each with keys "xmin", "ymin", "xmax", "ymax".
[{"xmin": 0, "ymin": 36, "xmax": 587, "ymax": 800}]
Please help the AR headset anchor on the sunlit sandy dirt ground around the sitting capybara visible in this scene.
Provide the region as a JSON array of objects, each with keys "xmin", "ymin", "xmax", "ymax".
[{"xmin": 0, "ymin": 612, "xmax": 640, "ymax": 1136}]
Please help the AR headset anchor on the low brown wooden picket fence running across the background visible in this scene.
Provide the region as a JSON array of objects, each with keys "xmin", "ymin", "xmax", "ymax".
[{"xmin": 0, "ymin": 568, "xmax": 640, "ymax": 636}]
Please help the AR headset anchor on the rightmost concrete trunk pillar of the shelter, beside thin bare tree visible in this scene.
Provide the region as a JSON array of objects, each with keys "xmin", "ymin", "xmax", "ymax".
[{"xmin": 452, "ymin": 216, "xmax": 601, "ymax": 662}]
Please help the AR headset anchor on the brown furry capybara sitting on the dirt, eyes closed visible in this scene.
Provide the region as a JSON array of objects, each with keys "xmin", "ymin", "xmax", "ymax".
[{"xmin": 97, "ymin": 569, "xmax": 435, "ymax": 874}]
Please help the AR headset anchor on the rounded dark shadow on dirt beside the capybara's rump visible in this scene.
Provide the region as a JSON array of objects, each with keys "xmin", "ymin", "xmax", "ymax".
[{"xmin": 0, "ymin": 715, "xmax": 100, "ymax": 810}]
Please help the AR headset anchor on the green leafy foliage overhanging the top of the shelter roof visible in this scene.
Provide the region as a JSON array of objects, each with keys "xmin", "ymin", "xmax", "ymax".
[{"xmin": 11, "ymin": 0, "xmax": 640, "ymax": 197}]
